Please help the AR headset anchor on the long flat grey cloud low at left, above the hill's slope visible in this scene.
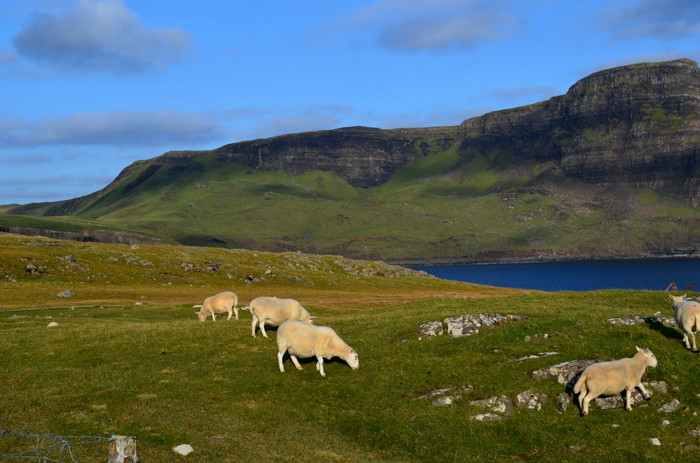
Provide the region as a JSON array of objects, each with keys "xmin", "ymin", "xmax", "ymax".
[{"xmin": 0, "ymin": 111, "xmax": 221, "ymax": 148}]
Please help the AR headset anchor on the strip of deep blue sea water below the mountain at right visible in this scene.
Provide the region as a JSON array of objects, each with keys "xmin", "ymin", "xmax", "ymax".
[{"xmin": 412, "ymin": 257, "xmax": 700, "ymax": 291}]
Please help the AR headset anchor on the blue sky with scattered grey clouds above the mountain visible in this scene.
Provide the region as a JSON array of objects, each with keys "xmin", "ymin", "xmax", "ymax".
[{"xmin": 0, "ymin": 0, "xmax": 700, "ymax": 204}]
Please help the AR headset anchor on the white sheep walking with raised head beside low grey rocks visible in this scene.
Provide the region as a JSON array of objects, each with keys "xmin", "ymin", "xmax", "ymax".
[{"xmin": 574, "ymin": 347, "xmax": 658, "ymax": 415}]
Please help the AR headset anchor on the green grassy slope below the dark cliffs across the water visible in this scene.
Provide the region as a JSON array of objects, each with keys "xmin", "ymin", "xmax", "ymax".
[{"xmin": 0, "ymin": 149, "xmax": 700, "ymax": 262}]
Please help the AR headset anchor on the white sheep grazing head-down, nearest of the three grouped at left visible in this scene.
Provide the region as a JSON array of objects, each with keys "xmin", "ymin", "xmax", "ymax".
[{"xmin": 277, "ymin": 320, "xmax": 360, "ymax": 377}]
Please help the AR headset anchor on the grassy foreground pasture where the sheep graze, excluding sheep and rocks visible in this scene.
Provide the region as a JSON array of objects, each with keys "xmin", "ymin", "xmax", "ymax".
[{"xmin": 0, "ymin": 234, "xmax": 700, "ymax": 462}]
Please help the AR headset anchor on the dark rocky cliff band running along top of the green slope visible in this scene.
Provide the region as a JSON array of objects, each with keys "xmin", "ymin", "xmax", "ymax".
[{"xmin": 108, "ymin": 59, "xmax": 700, "ymax": 207}]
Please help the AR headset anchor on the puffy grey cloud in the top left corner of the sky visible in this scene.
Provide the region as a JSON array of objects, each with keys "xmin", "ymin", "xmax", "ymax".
[{"xmin": 14, "ymin": 0, "xmax": 189, "ymax": 73}]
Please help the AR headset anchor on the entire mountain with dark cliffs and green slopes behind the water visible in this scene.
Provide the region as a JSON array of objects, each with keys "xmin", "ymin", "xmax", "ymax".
[{"xmin": 0, "ymin": 59, "xmax": 700, "ymax": 261}]
